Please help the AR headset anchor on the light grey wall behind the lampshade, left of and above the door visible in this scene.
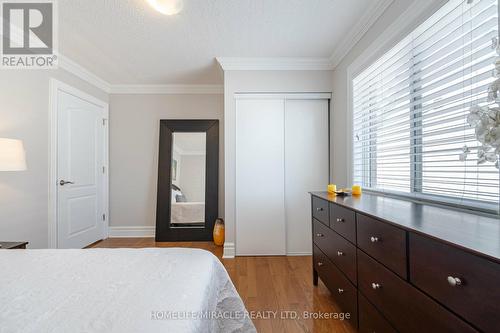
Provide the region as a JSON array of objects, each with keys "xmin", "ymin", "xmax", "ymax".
[{"xmin": 0, "ymin": 69, "xmax": 108, "ymax": 248}]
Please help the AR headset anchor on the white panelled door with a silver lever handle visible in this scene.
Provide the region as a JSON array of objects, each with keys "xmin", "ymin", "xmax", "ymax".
[{"xmin": 56, "ymin": 90, "xmax": 107, "ymax": 248}]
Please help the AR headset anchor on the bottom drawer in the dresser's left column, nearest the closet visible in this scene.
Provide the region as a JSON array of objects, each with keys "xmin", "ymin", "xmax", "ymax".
[{"xmin": 313, "ymin": 246, "xmax": 358, "ymax": 327}]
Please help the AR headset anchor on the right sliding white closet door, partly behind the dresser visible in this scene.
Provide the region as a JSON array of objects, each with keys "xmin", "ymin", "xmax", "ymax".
[{"xmin": 285, "ymin": 99, "xmax": 329, "ymax": 255}]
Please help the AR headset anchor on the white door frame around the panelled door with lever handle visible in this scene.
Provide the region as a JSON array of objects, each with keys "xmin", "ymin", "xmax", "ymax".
[{"xmin": 48, "ymin": 78, "xmax": 109, "ymax": 249}]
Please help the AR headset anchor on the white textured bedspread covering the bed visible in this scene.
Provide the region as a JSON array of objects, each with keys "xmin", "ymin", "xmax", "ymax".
[{"xmin": 0, "ymin": 248, "xmax": 255, "ymax": 333}]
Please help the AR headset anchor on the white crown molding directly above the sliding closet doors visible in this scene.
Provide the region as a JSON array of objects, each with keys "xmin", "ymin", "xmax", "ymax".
[{"xmin": 216, "ymin": 57, "xmax": 333, "ymax": 71}]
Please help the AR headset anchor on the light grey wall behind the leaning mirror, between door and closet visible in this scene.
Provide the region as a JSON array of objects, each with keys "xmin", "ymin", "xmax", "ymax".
[{"xmin": 110, "ymin": 94, "xmax": 224, "ymax": 230}]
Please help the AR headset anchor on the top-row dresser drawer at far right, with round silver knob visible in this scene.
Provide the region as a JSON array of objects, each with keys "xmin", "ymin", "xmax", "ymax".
[{"xmin": 410, "ymin": 233, "xmax": 500, "ymax": 332}]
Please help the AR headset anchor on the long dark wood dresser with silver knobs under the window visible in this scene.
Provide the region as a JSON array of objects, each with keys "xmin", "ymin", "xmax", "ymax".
[{"xmin": 311, "ymin": 192, "xmax": 500, "ymax": 333}]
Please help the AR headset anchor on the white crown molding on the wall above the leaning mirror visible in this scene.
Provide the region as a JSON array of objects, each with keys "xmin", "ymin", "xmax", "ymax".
[{"xmin": 110, "ymin": 84, "xmax": 224, "ymax": 95}]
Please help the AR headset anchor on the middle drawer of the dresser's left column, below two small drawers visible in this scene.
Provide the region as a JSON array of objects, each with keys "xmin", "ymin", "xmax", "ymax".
[{"xmin": 313, "ymin": 219, "xmax": 357, "ymax": 285}]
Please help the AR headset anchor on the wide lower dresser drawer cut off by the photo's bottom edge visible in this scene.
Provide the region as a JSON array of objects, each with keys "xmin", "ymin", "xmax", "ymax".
[{"xmin": 358, "ymin": 250, "xmax": 477, "ymax": 333}]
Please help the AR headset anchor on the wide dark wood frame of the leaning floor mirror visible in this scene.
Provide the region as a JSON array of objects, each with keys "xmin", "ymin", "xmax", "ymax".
[{"xmin": 155, "ymin": 119, "xmax": 219, "ymax": 242}]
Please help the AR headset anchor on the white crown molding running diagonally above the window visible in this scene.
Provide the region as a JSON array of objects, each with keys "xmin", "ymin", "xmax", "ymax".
[{"xmin": 329, "ymin": 0, "xmax": 394, "ymax": 68}]
